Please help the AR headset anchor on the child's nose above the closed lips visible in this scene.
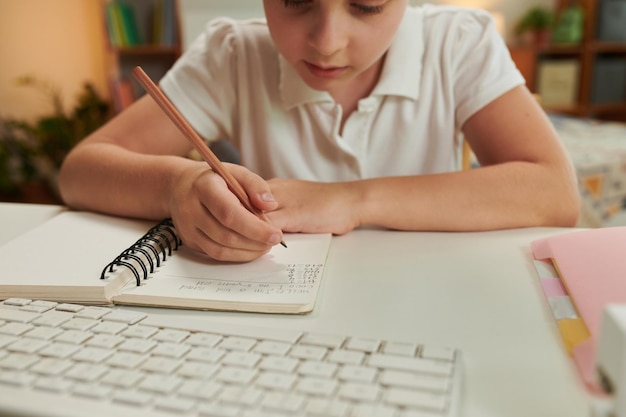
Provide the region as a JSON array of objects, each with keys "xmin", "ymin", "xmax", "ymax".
[{"xmin": 309, "ymin": 14, "xmax": 348, "ymax": 56}]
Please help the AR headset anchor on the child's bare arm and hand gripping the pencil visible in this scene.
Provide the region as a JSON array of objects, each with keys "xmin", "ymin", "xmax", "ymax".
[{"xmin": 59, "ymin": 96, "xmax": 282, "ymax": 261}]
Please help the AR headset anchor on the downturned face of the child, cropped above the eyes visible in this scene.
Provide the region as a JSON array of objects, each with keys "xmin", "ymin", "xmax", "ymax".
[{"xmin": 263, "ymin": 0, "xmax": 408, "ymax": 97}]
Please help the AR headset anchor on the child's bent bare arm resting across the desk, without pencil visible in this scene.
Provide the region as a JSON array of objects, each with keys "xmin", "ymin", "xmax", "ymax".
[{"xmin": 269, "ymin": 87, "xmax": 579, "ymax": 234}]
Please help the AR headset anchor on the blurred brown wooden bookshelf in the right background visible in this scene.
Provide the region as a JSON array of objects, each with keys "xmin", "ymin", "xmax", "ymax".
[{"xmin": 509, "ymin": 0, "xmax": 626, "ymax": 121}]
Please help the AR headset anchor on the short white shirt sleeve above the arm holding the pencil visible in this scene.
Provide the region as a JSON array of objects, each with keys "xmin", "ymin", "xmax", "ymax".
[{"xmin": 160, "ymin": 18, "xmax": 237, "ymax": 141}]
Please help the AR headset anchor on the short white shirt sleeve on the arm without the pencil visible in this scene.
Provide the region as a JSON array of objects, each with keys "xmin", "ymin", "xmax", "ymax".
[{"xmin": 446, "ymin": 9, "xmax": 525, "ymax": 126}]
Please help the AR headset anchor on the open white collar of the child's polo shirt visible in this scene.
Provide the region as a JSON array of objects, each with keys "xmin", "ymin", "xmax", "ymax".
[{"xmin": 278, "ymin": 7, "xmax": 424, "ymax": 109}]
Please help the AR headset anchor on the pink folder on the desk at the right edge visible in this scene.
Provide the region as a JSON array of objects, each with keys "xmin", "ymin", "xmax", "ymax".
[{"xmin": 531, "ymin": 227, "xmax": 626, "ymax": 391}]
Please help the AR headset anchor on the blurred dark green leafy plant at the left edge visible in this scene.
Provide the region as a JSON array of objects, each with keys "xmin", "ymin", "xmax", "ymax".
[{"xmin": 0, "ymin": 76, "xmax": 110, "ymax": 202}]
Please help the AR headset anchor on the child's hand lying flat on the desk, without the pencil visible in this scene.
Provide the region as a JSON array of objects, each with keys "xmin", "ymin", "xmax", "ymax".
[{"xmin": 267, "ymin": 179, "xmax": 360, "ymax": 236}]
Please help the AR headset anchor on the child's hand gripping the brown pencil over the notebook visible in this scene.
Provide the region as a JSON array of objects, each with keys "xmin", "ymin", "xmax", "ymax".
[{"xmin": 170, "ymin": 162, "xmax": 282, "ymax": 262}]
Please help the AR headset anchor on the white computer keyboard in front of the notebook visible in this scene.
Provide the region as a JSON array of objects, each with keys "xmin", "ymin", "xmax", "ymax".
[{"xmin": 0, "ymin": 298, "xmax": 462, "ymax": 417}]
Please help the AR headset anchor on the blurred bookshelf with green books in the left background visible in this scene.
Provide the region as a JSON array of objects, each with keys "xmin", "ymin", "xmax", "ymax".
[{"xmin": 100, "ymin": 0, "xmax": 182, "ymax": 112}]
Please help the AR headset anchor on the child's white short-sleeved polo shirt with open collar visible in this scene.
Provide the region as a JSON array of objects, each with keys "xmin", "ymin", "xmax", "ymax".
[{"xmin": 161, "ymin": 5, "xmax": 524, "ymax": 181}]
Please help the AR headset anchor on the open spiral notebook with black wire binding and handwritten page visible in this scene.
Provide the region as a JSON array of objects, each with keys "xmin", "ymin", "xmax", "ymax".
[{"xmin": 0, "ymin": 211, "xmax": 331, "ymax": 314}]
